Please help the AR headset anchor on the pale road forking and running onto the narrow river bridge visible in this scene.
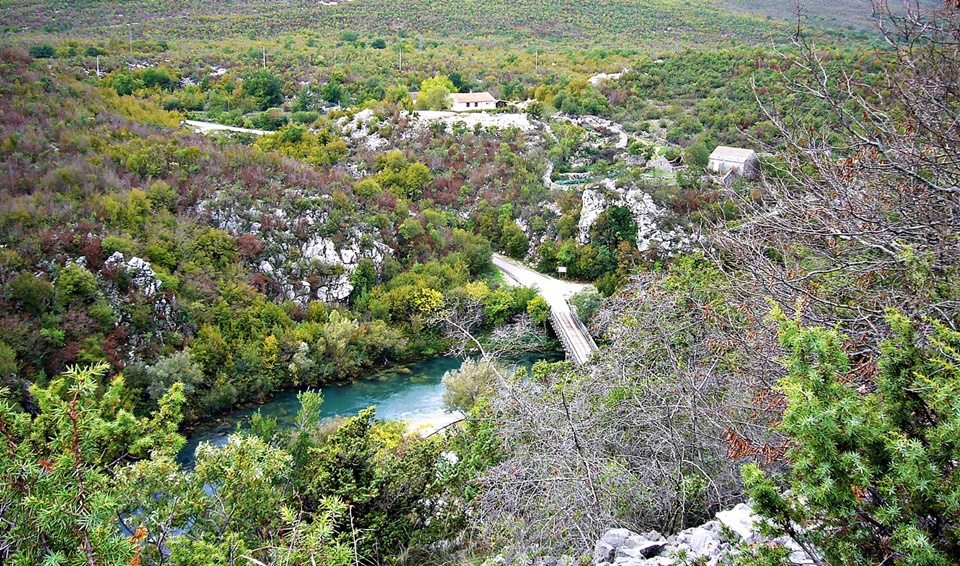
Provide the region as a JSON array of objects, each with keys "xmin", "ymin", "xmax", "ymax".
[{"xmin": 493, "ymin": 254, "xmax": 597, "ymax": 365}]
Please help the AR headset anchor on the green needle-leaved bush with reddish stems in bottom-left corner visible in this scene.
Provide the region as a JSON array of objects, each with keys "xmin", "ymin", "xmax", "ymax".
[{"xmin": 0, "ymin": 364, "xmax": 183, "ymax": 566}]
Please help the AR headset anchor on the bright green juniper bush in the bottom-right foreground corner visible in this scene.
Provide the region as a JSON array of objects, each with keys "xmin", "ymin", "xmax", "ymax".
[{"xmin": 744, "ymin": 312, "xmax": 960, "ymax": 566}]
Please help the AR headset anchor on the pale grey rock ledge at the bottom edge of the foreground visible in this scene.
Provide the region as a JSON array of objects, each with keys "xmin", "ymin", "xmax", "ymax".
[{"xmin": 593, "ymin": 503, "xmax": 814, "ymax": 566}]
